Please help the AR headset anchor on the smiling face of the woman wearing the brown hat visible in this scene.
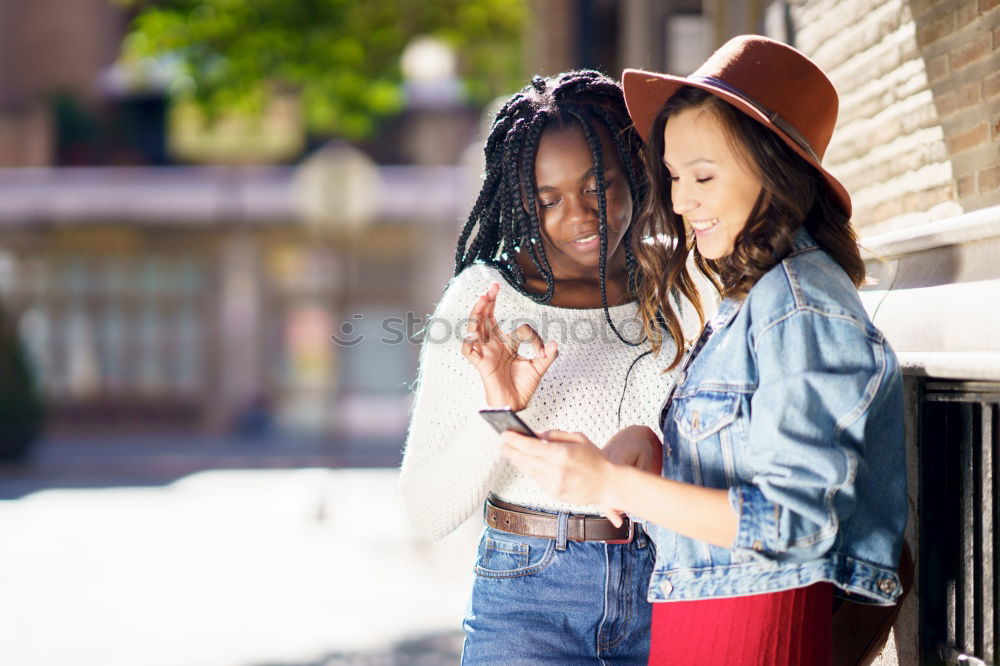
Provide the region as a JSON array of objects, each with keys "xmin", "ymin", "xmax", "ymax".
[{"xmin": 663, "ymin": 107, "xmax": 761, "ymax": 259}]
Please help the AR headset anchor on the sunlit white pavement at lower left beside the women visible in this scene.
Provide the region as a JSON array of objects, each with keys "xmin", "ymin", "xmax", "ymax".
[{"xmin": 0, "ymin": 468, "xmax": 480, "ymax": 666}]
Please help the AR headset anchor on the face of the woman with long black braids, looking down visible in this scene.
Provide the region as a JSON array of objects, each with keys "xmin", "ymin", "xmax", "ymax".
[{"xmin": 535, "ymin": 124, "xmax": 632, "ymax": 280}]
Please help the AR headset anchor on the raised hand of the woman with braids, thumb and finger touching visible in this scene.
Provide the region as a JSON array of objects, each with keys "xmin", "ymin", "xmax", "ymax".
[{"xmin": 462, "ymin": 282, "xmax": 559, "ymax": 411}]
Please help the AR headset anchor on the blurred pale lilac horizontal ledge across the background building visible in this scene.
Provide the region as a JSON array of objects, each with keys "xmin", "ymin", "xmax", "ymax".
[{"xmin": 0, "ymin": 166, "xmax": 471, "ymax": 228}]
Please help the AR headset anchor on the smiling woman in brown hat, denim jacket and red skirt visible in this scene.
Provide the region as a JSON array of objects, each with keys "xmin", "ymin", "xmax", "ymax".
[{"xmin": 504, "ymin": 36, "xmax": 907, "ymax": 666}]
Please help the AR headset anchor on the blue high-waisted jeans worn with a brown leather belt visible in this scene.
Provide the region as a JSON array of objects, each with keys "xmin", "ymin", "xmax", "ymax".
[{"xmin": 462, "ymin": 525, "xmax": 655, "ymax": 666}]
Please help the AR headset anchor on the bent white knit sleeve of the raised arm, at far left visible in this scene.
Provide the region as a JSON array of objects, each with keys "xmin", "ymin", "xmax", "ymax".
[{"xmin": 400, "ymin": 266, "xmax": 506, "ymax": 539}]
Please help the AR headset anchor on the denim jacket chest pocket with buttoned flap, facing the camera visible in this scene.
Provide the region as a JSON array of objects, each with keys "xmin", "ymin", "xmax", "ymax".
[{"xmin": 673, "ymin": 390, "xmax": 742, "ymax": 488}]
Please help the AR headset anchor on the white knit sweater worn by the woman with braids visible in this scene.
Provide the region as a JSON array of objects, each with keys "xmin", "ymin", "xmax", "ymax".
[{"xmin": 400, "ymin": 264, "xmax": 697, "ymax": 539}]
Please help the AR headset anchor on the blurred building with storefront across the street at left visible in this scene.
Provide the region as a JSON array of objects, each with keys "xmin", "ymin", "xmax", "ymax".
[{"xmin": 0, "ymin": 0, "xmax": 477, "ymax": 451}]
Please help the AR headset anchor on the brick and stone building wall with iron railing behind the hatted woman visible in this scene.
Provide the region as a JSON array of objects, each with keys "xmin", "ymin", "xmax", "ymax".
[{"xmin": 787, "ymin": 0, "xmax": 1000, "ymax": 664}]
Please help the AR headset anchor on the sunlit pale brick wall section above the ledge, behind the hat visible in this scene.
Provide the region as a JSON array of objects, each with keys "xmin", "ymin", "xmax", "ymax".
[{"xmin": 792, "ymin": 0, "xmax": 1000, "ymax": 233}]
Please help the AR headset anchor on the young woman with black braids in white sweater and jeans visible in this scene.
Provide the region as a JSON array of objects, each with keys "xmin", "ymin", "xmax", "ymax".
[{"xmin": 401, "ymin": 71, "xmax": 696, "ymax": 664}]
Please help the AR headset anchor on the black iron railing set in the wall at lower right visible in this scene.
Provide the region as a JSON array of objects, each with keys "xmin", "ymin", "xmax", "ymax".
[{"xmin": 919, "ymin": 381, "xmax": 1000, "ymax": 665}]
